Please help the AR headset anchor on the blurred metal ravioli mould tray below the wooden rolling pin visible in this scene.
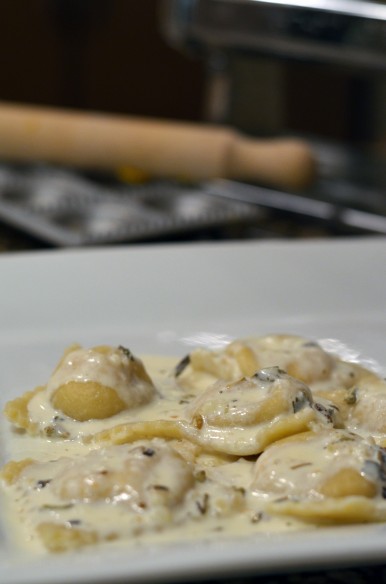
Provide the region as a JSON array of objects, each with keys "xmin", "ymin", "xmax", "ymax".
[{"xmin": 0, "ymin": 165, "xmax": 262, "ymax": 247}]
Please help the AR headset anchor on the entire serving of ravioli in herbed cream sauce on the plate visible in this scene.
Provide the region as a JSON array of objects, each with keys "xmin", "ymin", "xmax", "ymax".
[{"xmin": 0, "ymin": 334, "xmax": 386, "ymax": 552}]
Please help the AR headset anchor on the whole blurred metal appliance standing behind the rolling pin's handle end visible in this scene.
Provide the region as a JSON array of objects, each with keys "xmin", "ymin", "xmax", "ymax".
[{"xmin": 160, "ymin": 0, "xmax": 386, "ymax": 233}]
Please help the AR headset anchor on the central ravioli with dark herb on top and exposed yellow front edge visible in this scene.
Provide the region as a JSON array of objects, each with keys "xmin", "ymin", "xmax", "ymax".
[{"xmin": 176, "ymin": 367, "xmax": 335, "ymax": 456}]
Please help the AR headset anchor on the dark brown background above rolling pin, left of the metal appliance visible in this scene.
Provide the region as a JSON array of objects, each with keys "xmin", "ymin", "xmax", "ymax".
[{"xmin": 0, "ymin": 0, "xmax": 205, "ymax": 120}]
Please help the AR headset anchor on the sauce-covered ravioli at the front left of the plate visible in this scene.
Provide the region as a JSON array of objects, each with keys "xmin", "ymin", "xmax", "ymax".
[{"xmin": 1, "ymin": 439, "xmax": 244, "ymax": 552}]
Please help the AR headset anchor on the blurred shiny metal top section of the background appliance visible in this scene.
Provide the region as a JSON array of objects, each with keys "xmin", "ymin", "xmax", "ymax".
[{"xmin": 161, "ymin": 0, "xmax": 386, "ymax": 70}]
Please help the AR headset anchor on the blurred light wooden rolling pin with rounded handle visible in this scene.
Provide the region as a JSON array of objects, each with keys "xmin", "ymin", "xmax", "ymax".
[{"xmin": 0, "ymin": 102, "xmax": 315, "ymax": 189}]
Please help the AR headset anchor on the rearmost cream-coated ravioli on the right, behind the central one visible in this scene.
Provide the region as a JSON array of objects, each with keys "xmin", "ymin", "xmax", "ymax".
[{"xmin": 175, "ymin": 334, "xmax": 374, "ymax": 434}]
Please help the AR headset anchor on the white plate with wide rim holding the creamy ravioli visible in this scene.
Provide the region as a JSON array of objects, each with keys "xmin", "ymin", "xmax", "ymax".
[{"xmin": 0, "ymin": 238, "xmax": 386, "ymax": 584}]
